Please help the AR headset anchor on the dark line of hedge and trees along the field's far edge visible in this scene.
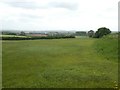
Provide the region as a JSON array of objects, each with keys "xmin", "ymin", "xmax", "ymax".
[{"xmin": 2, "ymin": 27, "xmax": 111, "ymax": 40}]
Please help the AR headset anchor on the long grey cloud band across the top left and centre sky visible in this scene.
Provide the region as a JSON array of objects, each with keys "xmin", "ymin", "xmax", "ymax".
[{"xmin": 4, "ymin": 2, "xmax": 78, "ymax": 10}]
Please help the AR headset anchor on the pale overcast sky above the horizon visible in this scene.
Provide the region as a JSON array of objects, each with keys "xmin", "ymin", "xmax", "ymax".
[{"xmin": 0, "ymin": 0, "xmax": 119, "ymax": 31}]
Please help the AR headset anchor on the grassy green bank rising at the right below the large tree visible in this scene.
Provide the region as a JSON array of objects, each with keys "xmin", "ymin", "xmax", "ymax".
[{"xmin": 95, "ymin": 34, "xmax": 118, "ymax": 61}]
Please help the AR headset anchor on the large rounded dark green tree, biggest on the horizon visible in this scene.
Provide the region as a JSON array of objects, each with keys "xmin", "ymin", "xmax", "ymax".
[{"xmin": 95, "ymin": 27, "xmax": 111, "ymax": 38}]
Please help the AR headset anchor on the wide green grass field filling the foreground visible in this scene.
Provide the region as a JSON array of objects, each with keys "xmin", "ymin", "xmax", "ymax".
[{"xmin": 2, "ymin": 38, "xmax": 118, "ymax": 88}]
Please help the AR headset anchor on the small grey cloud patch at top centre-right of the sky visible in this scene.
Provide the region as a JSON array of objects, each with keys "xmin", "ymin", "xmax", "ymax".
[{"xmin": 49, "ymin": 2, "xmax": 78, "ymax": 10}]
